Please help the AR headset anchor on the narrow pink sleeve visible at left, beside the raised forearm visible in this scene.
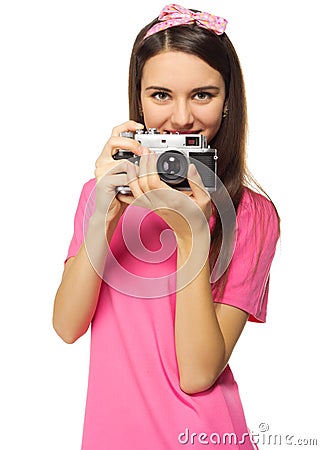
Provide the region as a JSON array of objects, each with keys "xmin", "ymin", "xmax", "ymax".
[{"xmin": 65, "ymin": 179, "xmax": 96, "ymax": 261}]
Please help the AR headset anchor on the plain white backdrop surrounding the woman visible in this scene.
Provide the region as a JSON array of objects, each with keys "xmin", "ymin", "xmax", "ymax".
[{"xmin": 0, "ymin": 0, "xmax": 321, "ymax": 450}]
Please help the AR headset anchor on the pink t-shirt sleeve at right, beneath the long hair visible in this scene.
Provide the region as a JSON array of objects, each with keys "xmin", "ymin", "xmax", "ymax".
[{"xmin": 213, "ymin": 189, "xmax": 279, "ymax": 322}]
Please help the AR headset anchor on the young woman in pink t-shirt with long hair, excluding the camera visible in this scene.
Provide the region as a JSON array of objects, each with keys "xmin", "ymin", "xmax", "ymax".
[{"xmin": 53, "ymin": 5, "xmax": 279, "ymax": 450}]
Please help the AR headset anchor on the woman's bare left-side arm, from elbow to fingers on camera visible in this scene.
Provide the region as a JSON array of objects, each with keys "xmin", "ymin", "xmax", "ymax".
[{"xmin": 53, "ymin": 120, "xmax": 144, "ymax": 343}]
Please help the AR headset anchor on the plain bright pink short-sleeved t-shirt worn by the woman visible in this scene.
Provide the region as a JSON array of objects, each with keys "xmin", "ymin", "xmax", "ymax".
[{"xmin": 67, "ymin": 180, "xmax": 279, "ymax": 450}]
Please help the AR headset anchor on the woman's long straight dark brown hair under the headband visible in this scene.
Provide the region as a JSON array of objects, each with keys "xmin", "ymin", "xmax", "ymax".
[{"xmin": 128, "ymin": 14, "xmax": 276, "ymax": 294}]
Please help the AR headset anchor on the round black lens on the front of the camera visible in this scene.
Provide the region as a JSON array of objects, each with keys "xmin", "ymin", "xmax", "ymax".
[{"xmin": 157, "ymin": 150, "xmax": 188, "ymax": 185}]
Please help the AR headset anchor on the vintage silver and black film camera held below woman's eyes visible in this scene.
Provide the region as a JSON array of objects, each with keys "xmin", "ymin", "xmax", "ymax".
[{"xmin": 113, "ymin": 128, "xmax": 218, "ymax": 194}]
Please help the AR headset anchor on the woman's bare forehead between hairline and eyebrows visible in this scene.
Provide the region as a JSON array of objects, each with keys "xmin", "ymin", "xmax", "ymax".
[{"xmin": 142, "ymin": 51, "xmax": 224, "ymax": 88}]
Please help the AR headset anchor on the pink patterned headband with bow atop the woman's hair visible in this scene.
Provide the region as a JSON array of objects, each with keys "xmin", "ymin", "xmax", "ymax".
[{"xmin": 145, "ymin": 3, "xmax": 227, "ymax": 39}]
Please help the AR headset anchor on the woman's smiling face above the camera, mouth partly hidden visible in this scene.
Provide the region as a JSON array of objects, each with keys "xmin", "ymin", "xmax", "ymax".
[{"xmin": 141, "ymin": 51, "xmax": 225, "ymax": 142}]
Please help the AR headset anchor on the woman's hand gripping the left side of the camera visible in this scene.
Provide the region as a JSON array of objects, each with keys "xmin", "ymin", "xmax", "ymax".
[{"xmin": 95, "ymin": 120, "xmax": 144, "ymax": 224}]
